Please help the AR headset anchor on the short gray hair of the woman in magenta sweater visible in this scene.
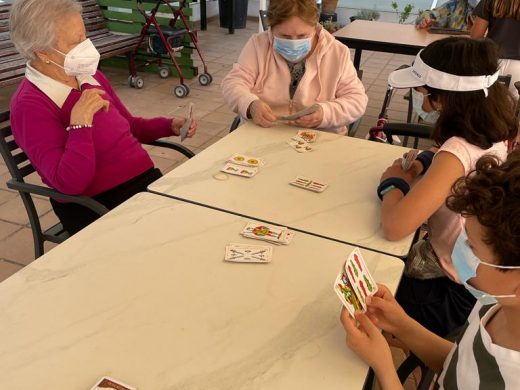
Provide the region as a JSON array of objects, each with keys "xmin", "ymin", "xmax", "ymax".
[{"xmin": 9, "ymin": 0, "xmax": 81, "ymax": 61}]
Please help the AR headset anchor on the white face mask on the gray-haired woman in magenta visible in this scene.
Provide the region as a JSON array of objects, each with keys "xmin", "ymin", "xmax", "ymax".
[{"xmin": 51, "ymin": 39, "xmax": 100, "ymax": 76}]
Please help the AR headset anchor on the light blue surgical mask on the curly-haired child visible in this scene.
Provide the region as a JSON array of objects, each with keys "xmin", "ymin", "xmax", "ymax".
[{"xmin": 451, "ymin": 229, "xmax": 520, "ymax": 305}]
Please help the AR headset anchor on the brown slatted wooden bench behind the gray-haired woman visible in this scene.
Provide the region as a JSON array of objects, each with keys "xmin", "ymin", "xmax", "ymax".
[{"xmin": 0, "ymin": 0, "xmax": 139, "ymax": 88}]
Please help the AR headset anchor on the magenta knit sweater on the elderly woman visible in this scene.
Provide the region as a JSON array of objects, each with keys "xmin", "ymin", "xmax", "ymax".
[{"xmin": 11, "ymin": 71, "xmax": 172, "ymax": 196}]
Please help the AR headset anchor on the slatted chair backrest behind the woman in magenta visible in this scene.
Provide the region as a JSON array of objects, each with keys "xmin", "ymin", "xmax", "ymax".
[{"xmin": 0, "ymin": 111, "xmax": 35, "ymax": 182}]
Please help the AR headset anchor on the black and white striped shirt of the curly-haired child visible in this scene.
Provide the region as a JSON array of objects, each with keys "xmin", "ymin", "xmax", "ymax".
[{"xmin": 437, "ymin": 301, "xmax": 520, "ymax": 390}]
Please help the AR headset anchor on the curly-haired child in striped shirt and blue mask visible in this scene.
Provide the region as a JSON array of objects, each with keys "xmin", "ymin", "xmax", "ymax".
[{"xmin": 341, "ymin": 151, "xmax": 520, "ymax": 390}]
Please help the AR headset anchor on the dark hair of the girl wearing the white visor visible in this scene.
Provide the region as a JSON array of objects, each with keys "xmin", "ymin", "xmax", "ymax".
[{"xmin": 420, "ymin": 37, "xmax": 518, "ymax": 149}]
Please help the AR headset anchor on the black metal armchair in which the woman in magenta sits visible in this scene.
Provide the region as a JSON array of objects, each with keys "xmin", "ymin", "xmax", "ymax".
[{"xmin": 0, "ymin": 111, "xmax": 195, "ymax": 258}]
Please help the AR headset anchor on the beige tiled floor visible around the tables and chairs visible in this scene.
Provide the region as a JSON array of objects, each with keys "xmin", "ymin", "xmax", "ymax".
[{"xmin": 0, "ymin": 21, "xmax": 411, "ymax": 281}]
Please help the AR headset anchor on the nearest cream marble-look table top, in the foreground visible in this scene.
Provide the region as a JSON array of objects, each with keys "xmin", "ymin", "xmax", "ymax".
[{"xmin": 0, "ymin": 194, "xmax": 403, "ymax": 390}]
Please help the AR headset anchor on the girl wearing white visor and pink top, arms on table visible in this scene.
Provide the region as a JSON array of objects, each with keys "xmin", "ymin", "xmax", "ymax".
[{"xmin": 377, "ymin": 37, "xmax": 518, "ymax": 336}]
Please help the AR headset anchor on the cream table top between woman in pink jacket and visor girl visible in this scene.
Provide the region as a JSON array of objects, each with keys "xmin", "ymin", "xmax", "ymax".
[{"xmin": 148, "ymin": 123, "xmax": 413, "ymax": 256}]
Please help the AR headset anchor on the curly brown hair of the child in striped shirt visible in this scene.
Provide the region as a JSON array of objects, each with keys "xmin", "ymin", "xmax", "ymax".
[{"xmin": 446, "ymin": 151, "xmax": 520, "ymax": 266}]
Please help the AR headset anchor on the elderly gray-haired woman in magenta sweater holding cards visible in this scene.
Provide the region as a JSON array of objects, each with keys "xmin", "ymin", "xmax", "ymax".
[{"xmin": 10, "ymin": 0, "xmax": 197, "ymax": 234}]
